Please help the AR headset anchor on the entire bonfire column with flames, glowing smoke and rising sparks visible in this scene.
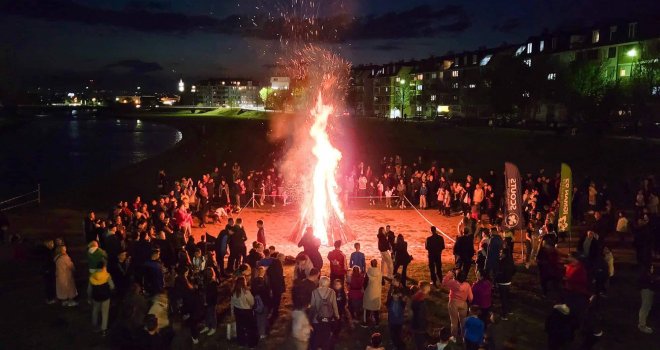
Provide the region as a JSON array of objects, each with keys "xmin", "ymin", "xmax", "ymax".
[{"xmin": 253, "ymin": 0, "xmax": 354, "ymax": 245}]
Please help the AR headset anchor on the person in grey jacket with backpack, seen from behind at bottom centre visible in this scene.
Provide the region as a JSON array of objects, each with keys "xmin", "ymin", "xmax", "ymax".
[{"xmin": 310, "ymin": 276, "xmax": 339, "ymax": 349}]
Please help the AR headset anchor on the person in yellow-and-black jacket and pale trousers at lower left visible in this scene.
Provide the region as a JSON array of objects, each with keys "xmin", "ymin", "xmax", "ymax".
[{"xmin": 87, "ymin": 261, "xmax": 115, "ymax": 336}]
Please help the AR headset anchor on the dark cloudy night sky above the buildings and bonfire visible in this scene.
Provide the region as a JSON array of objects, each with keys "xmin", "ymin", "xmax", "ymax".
[{"xmin": 0, "ymin": 0, "xmax": 660, "ymax": 91}]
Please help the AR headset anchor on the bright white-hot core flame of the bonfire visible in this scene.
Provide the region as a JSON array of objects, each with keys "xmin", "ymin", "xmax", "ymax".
[{"xmin": 302, "ymin": 91, "xmax": 344, "ymax": 245}]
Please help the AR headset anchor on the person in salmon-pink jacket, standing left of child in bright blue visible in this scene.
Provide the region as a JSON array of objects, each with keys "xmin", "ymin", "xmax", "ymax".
[{"xmin": 442, "ymin": 269, "xmax": 473, "ymax": 339}]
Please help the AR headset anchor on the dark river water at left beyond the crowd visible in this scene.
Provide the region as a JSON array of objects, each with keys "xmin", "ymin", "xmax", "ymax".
[{"xmin": 0, "ymin": 116, "xmax": 182, "ymax": 200}]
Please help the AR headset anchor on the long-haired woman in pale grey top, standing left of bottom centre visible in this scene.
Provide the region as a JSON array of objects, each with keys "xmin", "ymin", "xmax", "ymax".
[{"xmin": 231, "ymin": 276, "xmax": 259, "ymax": 348}]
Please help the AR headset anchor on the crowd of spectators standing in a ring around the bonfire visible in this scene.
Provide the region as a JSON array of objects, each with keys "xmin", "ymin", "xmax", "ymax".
[{"xmin": 31, "ymin": 156, "xmax": 660, "ymax": 350}]
